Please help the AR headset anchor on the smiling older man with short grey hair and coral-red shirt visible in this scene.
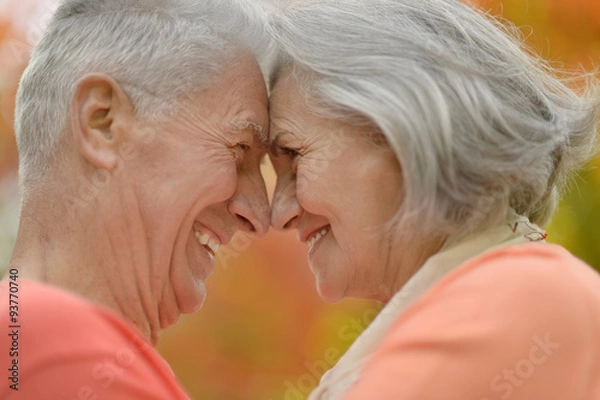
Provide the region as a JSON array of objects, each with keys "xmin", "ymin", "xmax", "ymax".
[{"xmin": 0, "ymin": 0, "xmax": 269, "ymax": 400}]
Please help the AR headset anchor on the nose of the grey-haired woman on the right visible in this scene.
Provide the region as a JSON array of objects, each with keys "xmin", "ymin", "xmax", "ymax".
[{"xmin": 271, "ymin": 177, "xmax": 302, "ymax": 231}]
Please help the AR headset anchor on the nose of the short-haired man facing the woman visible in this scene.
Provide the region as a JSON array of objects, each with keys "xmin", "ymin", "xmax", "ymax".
[{"xmin": 228, "ymin": 166, "xmax": 271, "ymax": 238}]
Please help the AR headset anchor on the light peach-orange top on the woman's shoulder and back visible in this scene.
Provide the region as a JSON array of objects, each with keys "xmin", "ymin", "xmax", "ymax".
[{"xmin": 343, "ymin": 243, "xmax": 600, "ymax": 400}]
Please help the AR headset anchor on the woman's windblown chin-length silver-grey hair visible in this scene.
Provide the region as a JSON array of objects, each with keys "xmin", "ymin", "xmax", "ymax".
[{"xmin": 270, "ymin": 0, "xmax": 600, "ymax": 235}]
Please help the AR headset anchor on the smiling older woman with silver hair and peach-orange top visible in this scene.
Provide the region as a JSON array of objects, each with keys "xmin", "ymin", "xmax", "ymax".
[{"xmin": 270, "ymin": 0, "xmax": 600, "ymax": 400}]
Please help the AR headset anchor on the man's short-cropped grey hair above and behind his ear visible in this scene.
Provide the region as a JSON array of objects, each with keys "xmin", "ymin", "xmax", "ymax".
[{"xmin": 15, "ymin": 0, "xmax": 267, "ymax": 191}]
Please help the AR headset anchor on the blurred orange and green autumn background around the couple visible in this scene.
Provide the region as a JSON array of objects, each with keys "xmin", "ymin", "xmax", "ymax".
[{"xmin": 0, "ymin": 0, "xmax": 600, "ymax": 400}]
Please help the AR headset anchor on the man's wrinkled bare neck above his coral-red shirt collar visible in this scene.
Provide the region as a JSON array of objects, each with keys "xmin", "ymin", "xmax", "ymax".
[{"xmin": 9, "ymin": 200, "xmax": 160, "ymax": 343}]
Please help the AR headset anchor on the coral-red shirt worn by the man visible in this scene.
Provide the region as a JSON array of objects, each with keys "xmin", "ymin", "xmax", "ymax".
[{"xmin": 0, "ymin": 275, "xmax": 189, "ymax": 400}]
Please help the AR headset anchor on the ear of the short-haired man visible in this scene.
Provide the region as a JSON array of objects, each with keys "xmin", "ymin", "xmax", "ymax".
[{"xmin": 70, "ymin": 74, "xmax": 133, "ymax": 171}]
